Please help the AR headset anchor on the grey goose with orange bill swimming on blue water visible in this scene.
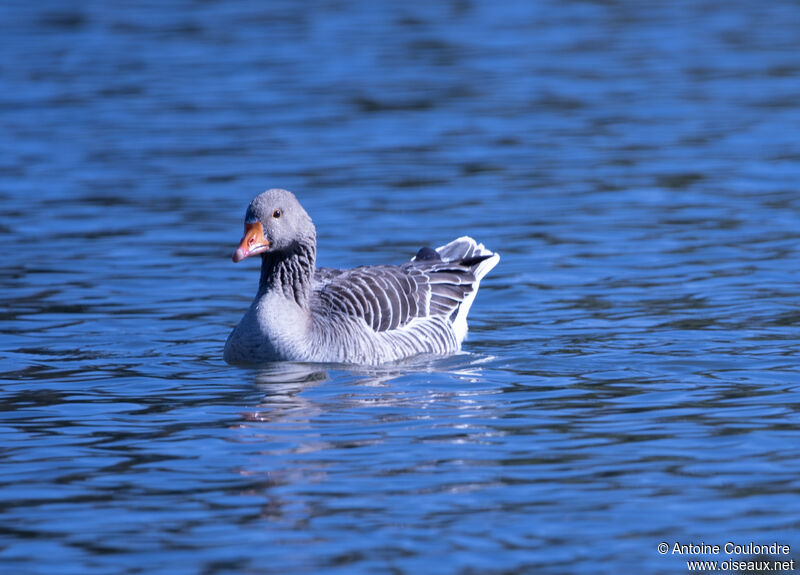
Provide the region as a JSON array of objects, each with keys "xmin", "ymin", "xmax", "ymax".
[{"xmin": 225, "ymin": 189, "xmax": 500, "ymax": 364}]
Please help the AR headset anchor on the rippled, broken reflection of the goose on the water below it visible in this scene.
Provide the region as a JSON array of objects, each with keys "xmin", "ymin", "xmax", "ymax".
[{"xmin": 236, "ymin": 354, "xmax": 506, "ymax": 528}]
